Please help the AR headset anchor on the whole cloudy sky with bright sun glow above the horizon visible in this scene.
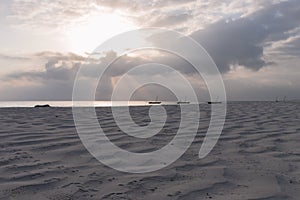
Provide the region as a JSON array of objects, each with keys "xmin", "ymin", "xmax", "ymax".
[{"xmin": 0, "ymin": 0, "xmax": 300, "ymax": 101}]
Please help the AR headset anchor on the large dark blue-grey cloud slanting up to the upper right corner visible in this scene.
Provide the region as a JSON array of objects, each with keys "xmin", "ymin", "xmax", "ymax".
[{"xmin": 191, "ymin": 1, "xmax": 300, "ymax": 72}]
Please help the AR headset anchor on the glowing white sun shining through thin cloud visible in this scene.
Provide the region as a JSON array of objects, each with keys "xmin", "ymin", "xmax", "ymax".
[{"xmin": 67, "ymin": 13, "xmax": 137, "ymax": 54}]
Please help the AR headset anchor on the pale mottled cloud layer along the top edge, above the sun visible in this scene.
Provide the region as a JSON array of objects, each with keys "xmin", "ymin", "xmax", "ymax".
[{"xmin": 9, "ymin": 0, "xmax": 278, "ymax": 33}]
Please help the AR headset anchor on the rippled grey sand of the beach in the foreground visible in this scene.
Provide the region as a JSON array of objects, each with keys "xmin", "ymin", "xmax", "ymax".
[{"xmin": 0, "ymin": 102, "xmax": 300, "ymax": 200}]
